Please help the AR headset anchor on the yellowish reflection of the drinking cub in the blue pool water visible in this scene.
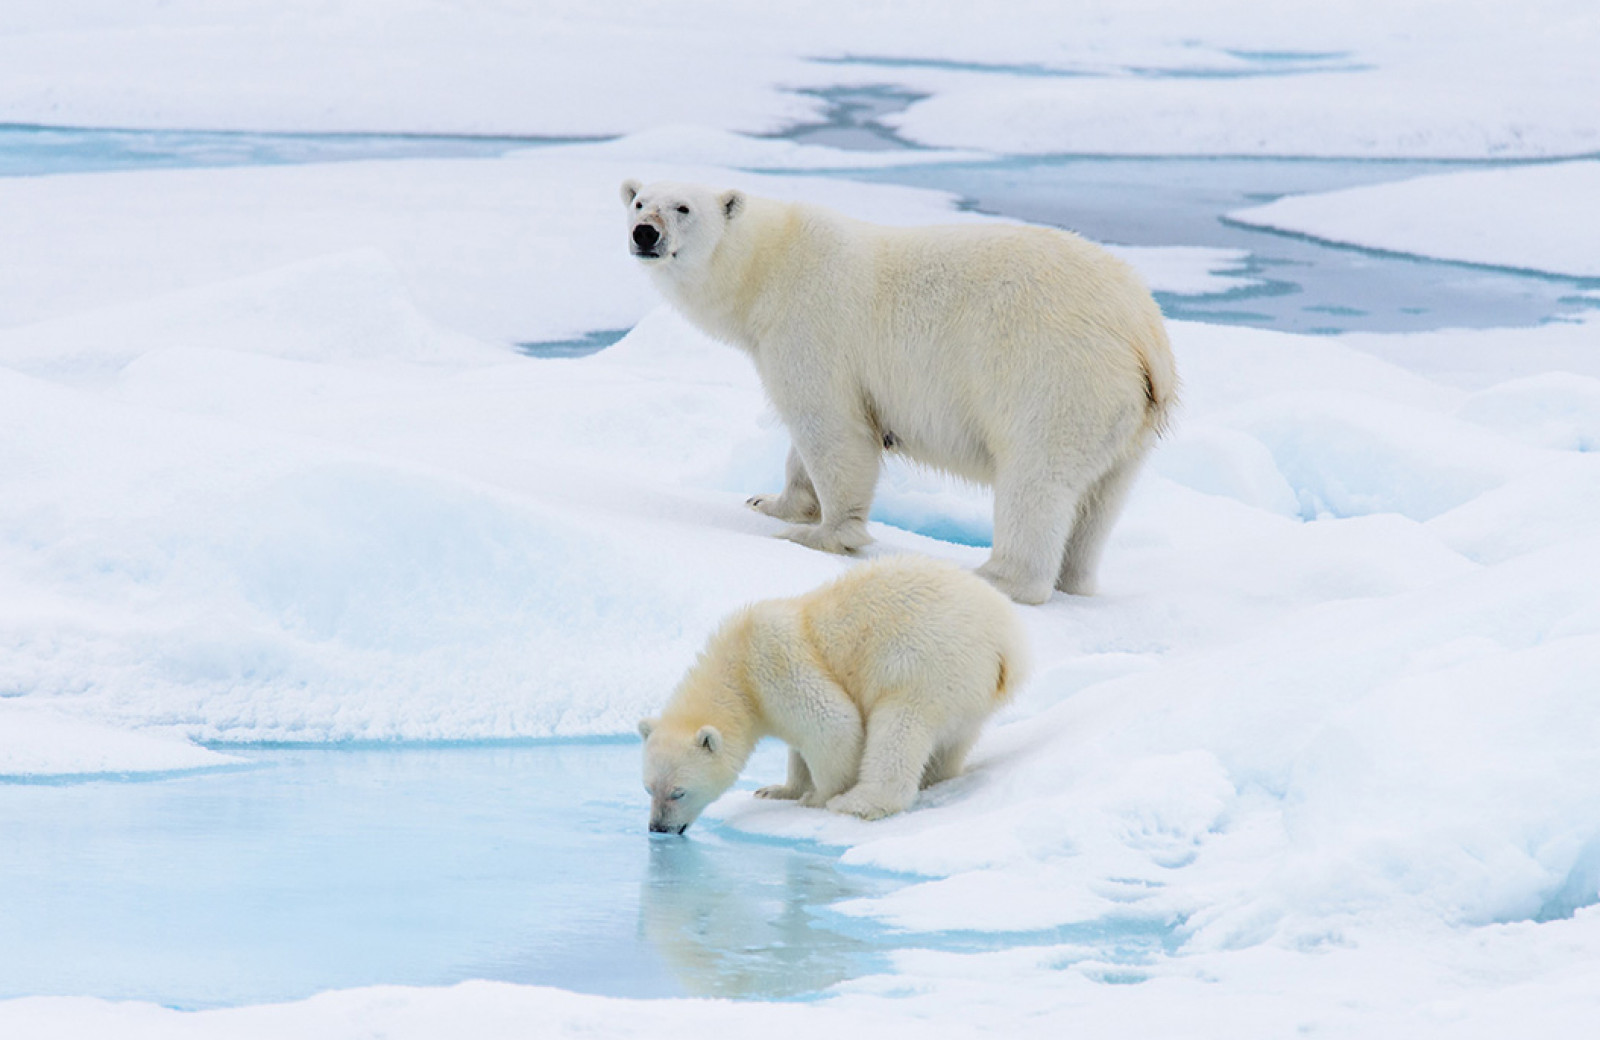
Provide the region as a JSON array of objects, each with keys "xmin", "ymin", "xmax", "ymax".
[{"xmin": 638, "ymin": 835, "xmax": 890, "ymax": 998}]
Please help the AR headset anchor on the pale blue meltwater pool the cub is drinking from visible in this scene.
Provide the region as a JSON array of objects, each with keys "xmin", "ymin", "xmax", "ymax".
[{"xmin": 0, "ymin": 741, "xmax": 899, "ymax": 1008}]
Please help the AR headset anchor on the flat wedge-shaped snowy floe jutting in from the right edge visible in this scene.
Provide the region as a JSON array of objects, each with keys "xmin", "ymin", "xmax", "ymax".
[{"xmin": 1229, "ymin": 162, "xmax": 1600, "ymax": 278}]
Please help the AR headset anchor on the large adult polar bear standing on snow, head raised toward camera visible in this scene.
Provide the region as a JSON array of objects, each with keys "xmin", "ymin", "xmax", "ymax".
[{"xmin": 622, "ymin": 181, "xmax": 1178, "ymax": 603}]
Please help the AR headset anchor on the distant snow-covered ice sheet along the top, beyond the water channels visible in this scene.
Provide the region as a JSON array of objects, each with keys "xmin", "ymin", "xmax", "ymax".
[{"xmin": 0, "ymin": 0, "xmax": 1600, "ymax": 157}]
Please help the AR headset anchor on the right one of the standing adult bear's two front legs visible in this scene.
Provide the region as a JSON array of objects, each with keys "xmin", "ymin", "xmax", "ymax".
[{"xmin": 781, "ymin": 416, "xmax": 883, "ymax": 552}]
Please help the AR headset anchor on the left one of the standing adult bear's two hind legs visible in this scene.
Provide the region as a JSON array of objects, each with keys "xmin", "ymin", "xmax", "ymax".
[{"xmin": 978, "ymin": 467, "xmax": 1078, "ymax": 603}]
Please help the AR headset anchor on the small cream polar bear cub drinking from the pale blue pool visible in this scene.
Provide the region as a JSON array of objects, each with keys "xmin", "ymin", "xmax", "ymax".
[{"xmin": 638, "ymin": 557, "xmax": 1024, "ymax": 834}]
